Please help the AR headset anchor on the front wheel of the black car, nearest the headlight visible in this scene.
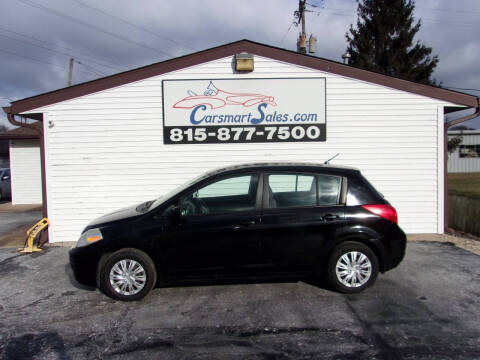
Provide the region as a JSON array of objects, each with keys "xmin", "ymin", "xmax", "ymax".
[{"xmin": 99, "ymin": 248, "xmax": 157, "ymax": 301}]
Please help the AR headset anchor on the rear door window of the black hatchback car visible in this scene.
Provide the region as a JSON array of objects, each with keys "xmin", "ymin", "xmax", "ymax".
[{"xmin": 268, "ymin": 174, "xmax": 317, "ymax": 208}]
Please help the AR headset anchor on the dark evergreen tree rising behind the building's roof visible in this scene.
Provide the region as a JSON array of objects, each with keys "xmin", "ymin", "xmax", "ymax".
[{"xmin": 346, "ymin": 0, "xmax": 438, "ymax": 84}]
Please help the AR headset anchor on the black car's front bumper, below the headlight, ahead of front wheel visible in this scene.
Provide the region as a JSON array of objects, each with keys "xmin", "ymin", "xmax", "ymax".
[{"xmin": 69, "ymin": 245, "xmax": 100, "ymax": 286}]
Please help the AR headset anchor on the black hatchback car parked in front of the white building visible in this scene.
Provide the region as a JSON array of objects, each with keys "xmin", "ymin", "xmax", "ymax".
[{"xmin": 70, "ymin": 163, "xmax": 406, "ymax": 300}]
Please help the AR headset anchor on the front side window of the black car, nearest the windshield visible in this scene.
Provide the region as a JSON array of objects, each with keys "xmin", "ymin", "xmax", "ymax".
[{"xmin": 180, "ymin": 174, "xmax": 258, "ymax": 216}]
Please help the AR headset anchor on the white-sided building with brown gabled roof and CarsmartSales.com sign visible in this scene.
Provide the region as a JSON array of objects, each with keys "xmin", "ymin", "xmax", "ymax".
[{"xmin": 1, "ymin": 40, "xmax": 479, "ymax": 242}]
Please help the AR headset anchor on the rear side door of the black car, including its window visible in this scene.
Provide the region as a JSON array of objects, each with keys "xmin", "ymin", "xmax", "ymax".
[{"xmin": 260, "ymin": 172, "xmax": 344, "ymax": 271}]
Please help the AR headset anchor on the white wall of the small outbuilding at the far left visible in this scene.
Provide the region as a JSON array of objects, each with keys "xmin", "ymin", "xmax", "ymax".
[{"xmin": 10, "ymin": 140, "xmax": 42, "ymax": 205}]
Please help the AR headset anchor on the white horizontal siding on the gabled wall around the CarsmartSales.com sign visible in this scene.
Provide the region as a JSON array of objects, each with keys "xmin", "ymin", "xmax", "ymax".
[{"xmin": 31, "ymin": 56, "xmax": 452, "ymax": 241}]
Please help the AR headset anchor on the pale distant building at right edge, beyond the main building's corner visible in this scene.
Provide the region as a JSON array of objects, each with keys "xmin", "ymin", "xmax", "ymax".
[{"xmin": 448, "ymin": 130, "xmax": 480, "ymax": 173}]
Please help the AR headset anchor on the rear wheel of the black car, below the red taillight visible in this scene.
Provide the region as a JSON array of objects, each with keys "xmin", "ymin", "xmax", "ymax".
[{"xmin": 327, "ymin": 241, "xmax": 378, "ymax": 294}]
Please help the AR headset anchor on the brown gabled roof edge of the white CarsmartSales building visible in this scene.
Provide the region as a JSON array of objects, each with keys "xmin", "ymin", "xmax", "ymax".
[{"xmin": 4, "ymin": 40, "xmax": 479, "ymax": 114}]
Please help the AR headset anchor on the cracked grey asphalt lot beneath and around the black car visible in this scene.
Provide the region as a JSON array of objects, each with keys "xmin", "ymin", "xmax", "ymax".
[{"xmin": 0, "ymin": 242, "xmax": 480, "ymax": 359}]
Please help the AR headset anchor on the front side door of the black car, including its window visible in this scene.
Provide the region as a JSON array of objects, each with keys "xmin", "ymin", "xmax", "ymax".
[{"xmin": 165, "ymin": 172, "xmax": 262, "ymax": 276}]
